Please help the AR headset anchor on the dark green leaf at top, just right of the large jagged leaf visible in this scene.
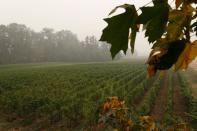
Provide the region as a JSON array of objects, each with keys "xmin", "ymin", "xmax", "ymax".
[{"xmin": 138, "ymin": 3, "xmax": 169, "ymax": 42}]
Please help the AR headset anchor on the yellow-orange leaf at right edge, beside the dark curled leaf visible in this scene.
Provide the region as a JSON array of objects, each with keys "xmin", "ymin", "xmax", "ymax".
[{"xmin": 175, "ymin": 40, "xmax": 197, "ymax": 70}]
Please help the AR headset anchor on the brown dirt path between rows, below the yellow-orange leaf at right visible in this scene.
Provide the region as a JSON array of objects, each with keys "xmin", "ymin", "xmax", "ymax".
[{"xmin": 173, "ymin": 74, "xmax": 189, "ymax": 122}]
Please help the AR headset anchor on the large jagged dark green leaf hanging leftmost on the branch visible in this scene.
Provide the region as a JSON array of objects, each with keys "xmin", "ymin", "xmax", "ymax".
[{"xmin": 100, "ymin": 4, "xmax": 138, "ymax": 58}]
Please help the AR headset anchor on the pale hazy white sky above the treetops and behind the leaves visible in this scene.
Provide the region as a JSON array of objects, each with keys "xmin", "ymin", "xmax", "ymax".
[{"xmin": 0, "ymin": 0, "xmax": 150, "ymax": 55}]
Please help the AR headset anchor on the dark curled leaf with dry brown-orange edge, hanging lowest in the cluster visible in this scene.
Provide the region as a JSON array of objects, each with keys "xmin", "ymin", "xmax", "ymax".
[{"xmin": 147, "ymin": 40, "xmax": 186, "ymax": 77}]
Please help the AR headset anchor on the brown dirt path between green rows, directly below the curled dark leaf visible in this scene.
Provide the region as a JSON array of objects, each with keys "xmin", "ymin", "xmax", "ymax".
[{"xmin": 150, "ymin": 72, "xmax": 168, "ymax": 121}]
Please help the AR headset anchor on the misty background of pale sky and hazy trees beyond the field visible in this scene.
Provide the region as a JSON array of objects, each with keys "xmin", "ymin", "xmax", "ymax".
[{"xmin": 0, "ymin": 0, "xmax": 150, "ymax": 63}]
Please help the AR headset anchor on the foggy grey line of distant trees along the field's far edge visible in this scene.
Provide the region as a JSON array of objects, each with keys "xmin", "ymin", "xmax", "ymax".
[{"xmin": 0, "ymin": 23, "xmax": 121, "ymax": 64}]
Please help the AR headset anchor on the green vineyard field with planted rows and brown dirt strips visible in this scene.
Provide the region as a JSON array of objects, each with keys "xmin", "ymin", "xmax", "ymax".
[{"xmin": 0, "ymin": 60, "xmax": 197, "ymax": 131}]
